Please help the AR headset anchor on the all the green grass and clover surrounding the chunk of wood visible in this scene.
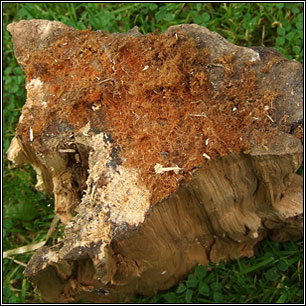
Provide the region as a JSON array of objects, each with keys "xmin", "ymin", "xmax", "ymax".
[{"xmin": 2, "ymin": 3, "xmax": 303, "ymax": 303}]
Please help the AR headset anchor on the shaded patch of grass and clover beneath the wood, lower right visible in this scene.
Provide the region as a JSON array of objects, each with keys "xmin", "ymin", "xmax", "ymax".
[{"xmin": 135, "ymin": 240, "xmax": 303, "ymax": 304}]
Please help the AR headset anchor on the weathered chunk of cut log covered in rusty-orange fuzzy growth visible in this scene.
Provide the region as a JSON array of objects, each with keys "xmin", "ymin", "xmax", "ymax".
[{"xmin": 7, "ymin": 20, "xmax": 303, "ymax": 302}]
